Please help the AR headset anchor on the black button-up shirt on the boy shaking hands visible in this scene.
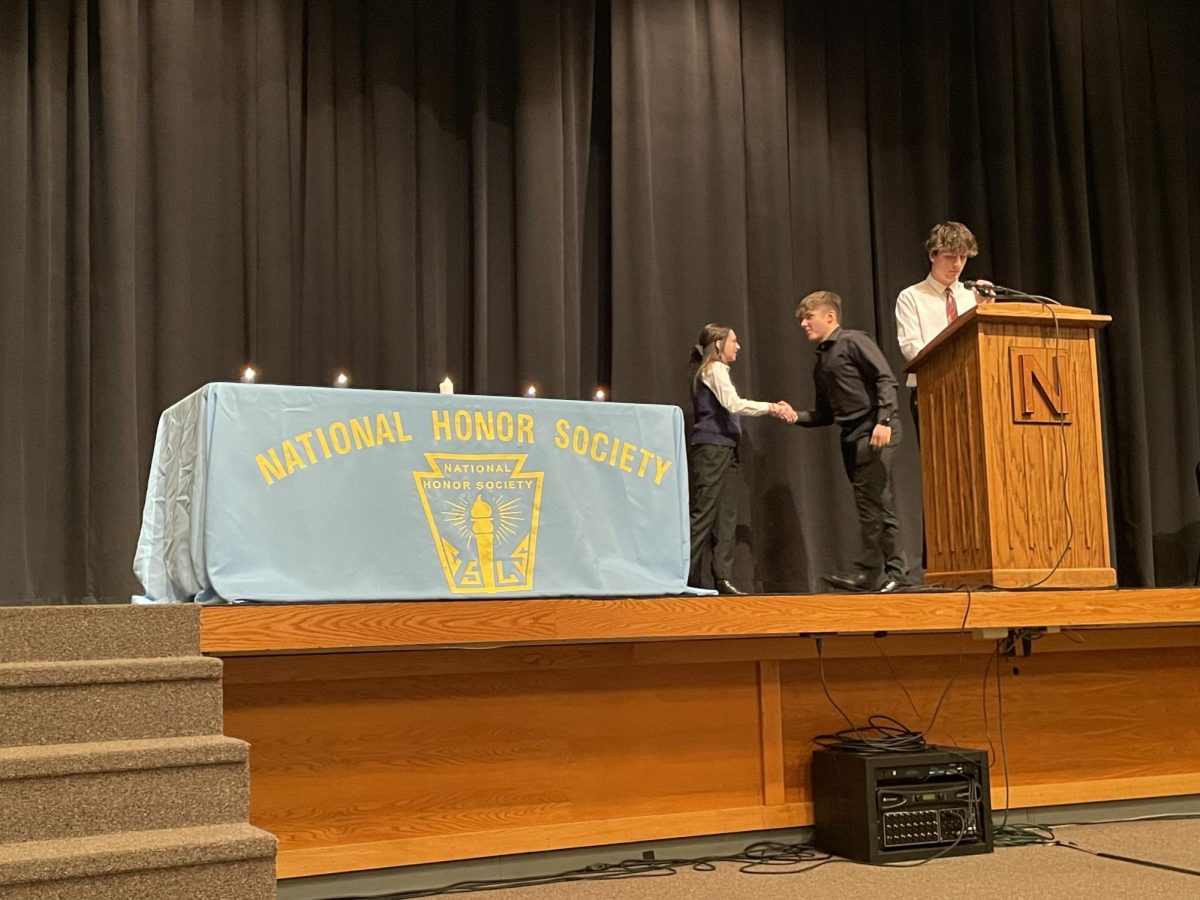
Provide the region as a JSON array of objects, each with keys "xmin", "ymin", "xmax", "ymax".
[{"xmin": 796, "ymin": 326, "xmax": 899, "ymax": 431}]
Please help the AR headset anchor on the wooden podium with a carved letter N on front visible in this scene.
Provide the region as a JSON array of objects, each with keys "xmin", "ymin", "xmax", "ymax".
[{"xmin": 905, "ymin": 302, "xmax": 1116, "ymax": 588}]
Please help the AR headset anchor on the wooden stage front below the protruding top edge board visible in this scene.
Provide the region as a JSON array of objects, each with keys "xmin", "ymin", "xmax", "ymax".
[{"xmin": 211, "ymin": 614, "xmax": 1200, "ymax": 877}]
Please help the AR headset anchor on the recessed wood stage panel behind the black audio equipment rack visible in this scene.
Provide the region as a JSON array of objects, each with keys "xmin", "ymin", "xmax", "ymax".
[{"xmin": 781, "ymin": 638, "xmax": 1200, "ymax": 804}]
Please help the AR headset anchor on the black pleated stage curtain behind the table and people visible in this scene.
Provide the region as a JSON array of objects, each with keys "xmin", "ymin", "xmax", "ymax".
[{"xmin": 0, "ymin": 0, "xmax": 1200, "ymax": 602}]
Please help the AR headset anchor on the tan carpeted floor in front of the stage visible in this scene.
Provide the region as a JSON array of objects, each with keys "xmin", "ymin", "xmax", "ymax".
[{"xmin": 470, "ymin": 820, "xmax": 1200, "ymax": 900}]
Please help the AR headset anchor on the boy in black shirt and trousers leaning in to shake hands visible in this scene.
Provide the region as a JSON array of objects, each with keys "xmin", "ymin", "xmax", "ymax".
[{"xmin": 796, "ymin": 290, "xmax": 906, "ymax": 592}]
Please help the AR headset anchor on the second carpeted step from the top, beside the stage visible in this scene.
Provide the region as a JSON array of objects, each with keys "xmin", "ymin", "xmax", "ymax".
[{"xmin": 0, "ymin": 656, "xmax": 222, "ymax": 746}]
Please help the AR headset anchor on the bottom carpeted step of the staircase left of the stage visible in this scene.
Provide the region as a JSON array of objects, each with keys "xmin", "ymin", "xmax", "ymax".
[{"xmin": 0, "ymin": 823, "xmax": 275, "ymax": 900}]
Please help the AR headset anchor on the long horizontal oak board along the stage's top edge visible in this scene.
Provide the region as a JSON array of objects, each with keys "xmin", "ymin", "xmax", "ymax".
[{"xmin": 200, "ymin": 588, "xmax": 1200, "ymax": 656}]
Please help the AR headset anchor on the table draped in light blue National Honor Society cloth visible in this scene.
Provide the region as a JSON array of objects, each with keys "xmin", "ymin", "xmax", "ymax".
[{"xmin": 133, "ymin": 383, "xmax": 690, "ymax": 602}]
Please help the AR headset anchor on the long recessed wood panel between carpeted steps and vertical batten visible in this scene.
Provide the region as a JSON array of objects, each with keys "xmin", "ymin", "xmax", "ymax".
[{"xmin": 224, "ymin": 655, "xmax": 763, "ymax": 853}]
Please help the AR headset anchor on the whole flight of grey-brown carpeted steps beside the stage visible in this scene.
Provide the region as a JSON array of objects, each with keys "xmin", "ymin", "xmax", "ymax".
[{"xmin": 0, "ymin": 604, "xmax": 276, "ymax": 900}]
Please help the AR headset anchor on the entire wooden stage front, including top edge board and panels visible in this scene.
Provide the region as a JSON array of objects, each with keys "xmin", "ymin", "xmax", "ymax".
[{"xmin": 202, "ymin": 588, "xmax": 1200, "ymax": 878}]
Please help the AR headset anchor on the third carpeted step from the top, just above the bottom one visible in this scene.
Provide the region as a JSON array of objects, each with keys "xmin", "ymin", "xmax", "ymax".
[{"xmin": 0, "ymin": 734, "xmax": 250, "ymax": 841}]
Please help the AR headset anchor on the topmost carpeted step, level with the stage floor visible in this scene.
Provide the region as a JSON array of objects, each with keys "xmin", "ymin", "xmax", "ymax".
[{"xmin": 0, "ymin": 604, "xmax": 200, "ymax": 664}]
